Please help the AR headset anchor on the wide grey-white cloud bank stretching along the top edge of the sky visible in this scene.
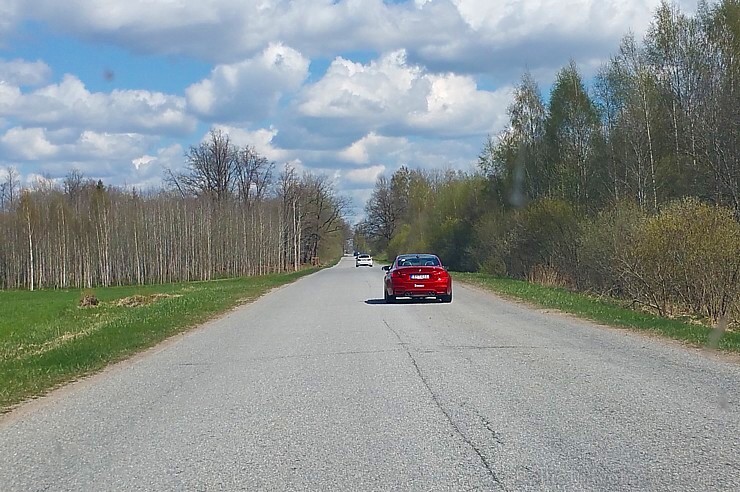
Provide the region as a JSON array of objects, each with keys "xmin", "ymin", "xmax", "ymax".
[{"xmin": 17, "ymin": 0, "xmax": 696, "ymax": 72}]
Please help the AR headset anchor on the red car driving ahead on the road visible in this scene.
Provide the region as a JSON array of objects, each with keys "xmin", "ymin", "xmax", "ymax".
[{"xmin": 383, "ymin": 254, "xmax": 452, "ymax": 303}]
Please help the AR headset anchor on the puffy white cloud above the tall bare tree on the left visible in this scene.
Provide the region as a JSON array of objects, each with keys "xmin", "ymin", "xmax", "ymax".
[{"xmin": 186, "ymin": 43, "xmax": 309, "ymax": 121}]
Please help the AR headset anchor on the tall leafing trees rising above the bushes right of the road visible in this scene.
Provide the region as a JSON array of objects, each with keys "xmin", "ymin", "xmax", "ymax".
[{"xmin": 479, "ymin": 0, "xmax": 740, "ymax": 219}]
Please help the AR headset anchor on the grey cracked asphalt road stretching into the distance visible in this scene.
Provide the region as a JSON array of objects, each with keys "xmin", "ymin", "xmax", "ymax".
[{"xmin": 0, "ymin": 258, "xmax": 740, "ymax": 492}]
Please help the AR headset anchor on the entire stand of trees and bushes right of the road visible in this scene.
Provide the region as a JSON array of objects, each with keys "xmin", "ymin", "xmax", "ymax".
[{"xmin": 362, "ymin": 0, "xmax": 740, "ymax": 326}]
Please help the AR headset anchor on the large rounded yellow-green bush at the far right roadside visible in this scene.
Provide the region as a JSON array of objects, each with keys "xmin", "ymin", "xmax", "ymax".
[{"xmin": 625, "ymin": 198, "xmax": 740, "ymax": 322}]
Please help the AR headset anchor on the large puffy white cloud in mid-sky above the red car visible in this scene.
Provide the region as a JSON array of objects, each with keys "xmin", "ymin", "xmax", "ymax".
[{"xmin": 299, "ymin": 51, "xmax": 511, "ymax": 136}]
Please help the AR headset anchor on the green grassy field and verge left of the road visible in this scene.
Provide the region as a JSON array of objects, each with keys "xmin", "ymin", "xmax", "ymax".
[{"xmin": 0, "ymin": 268, "xmax": 318, "ymax": 413}]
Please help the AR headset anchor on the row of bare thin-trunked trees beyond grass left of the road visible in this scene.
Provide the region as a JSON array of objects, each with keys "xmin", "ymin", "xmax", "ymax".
[{"xmin": 0, "ymin": 130, "xmax": 348, "ymax": 290}]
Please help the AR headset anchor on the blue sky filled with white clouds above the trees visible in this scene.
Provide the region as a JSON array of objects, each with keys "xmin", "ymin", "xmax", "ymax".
[{"xmin": 0, "ymin": 0, "xmax": 695, "ymax": 217}]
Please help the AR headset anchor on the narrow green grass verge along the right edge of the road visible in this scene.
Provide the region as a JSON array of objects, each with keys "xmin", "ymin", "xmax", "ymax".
[{"xmin": 453, "ymin": 273, "xmax": 740, "ymax": 353}]
